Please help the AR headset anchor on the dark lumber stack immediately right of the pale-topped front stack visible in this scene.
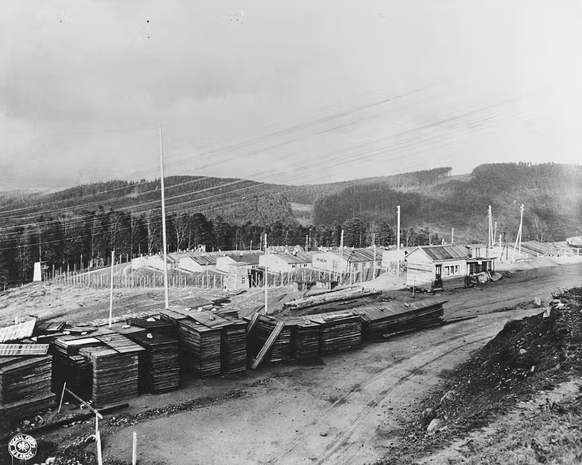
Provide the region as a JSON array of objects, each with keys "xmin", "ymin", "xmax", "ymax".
[{"xmin": 127, "ymin": 331, "xmax": 180, "ymax": 394}]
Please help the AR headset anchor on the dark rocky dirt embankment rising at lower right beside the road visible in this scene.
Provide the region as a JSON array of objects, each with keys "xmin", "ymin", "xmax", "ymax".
[{"xmin": 377, "ymin": 288, "xmax": 582, "ymax": 465}]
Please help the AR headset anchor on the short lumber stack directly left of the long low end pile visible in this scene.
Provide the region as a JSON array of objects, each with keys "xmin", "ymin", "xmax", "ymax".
[{"xmin": 307, "ymin": 311, "xmax": 362, "ymax": 355}]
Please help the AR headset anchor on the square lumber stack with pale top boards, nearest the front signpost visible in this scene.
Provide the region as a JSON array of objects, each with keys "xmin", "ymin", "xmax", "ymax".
[{"xmin": 79, "ymin": 333, "xmax": 144, "ymax": 407}]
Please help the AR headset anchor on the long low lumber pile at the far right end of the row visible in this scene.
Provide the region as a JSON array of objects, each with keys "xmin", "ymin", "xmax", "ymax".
[{"xmin": 354, "ymin": 301, "xmax": 446, "ymax": 339}]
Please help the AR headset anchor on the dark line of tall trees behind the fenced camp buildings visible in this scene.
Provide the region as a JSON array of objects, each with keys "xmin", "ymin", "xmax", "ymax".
[{"xmin": 0, "ymin": 206, "xmax": 440, "ymax": 285}]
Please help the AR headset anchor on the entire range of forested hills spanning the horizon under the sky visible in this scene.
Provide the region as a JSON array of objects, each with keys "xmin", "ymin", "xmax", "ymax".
[{"xmin": 0, "ymin": 163, "xmax": 582, "ymax": 240}]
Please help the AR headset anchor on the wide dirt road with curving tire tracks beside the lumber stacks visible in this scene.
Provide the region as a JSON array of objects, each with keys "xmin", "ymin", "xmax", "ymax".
[{"xmin": 105, "ymin": 262, "xmax": 582, "ymax": 465}]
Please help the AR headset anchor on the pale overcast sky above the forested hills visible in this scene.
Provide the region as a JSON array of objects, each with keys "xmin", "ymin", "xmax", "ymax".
[{"xmin": 0, "ymin": 0, "xmax": 582, "ymax": 190}]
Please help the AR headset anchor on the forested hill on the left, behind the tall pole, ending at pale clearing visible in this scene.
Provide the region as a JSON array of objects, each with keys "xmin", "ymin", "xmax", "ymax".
[{"xmin": 0, "ymin": 176, "xmax": 295, "ymax": 224}]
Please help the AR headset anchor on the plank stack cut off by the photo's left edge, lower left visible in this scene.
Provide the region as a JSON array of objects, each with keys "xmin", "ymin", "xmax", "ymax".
[{"xmin": 0, "ymin": 354, "xmax": 55, "ymax": 427}]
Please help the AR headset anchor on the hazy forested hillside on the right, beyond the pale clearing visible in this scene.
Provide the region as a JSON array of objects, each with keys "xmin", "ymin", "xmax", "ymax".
[{"xmin": 314, "ymin": 163, "xmax": 582, "ymax": 242}]
